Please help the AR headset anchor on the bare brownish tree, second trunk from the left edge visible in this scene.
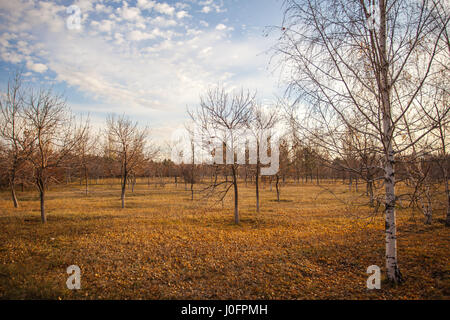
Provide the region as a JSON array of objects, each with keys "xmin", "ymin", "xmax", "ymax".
[{"xmin": 24, "ymin": 90, "xmax": 87, "ymax": 223}]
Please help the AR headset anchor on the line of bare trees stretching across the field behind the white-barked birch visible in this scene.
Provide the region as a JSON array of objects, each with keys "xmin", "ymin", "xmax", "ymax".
[{"xmin": 0, "ymin": 75, "xmax": 449, "ymax": 228}]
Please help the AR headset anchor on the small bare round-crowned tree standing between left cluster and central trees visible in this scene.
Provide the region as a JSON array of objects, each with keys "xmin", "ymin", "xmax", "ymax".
[{"xmin": 106, "ymin": 115, "xmax": 148, "ymax": 208}]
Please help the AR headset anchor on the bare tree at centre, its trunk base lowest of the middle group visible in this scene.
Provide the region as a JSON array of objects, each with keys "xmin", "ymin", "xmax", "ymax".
[{"xmin": 188, "ymin": 87, "xmax": 255, "ymax": 224}]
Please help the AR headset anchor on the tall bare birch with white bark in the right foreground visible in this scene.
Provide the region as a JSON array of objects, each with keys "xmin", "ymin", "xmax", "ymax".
[{"xmin": 277, "ymin": 0, "xmax": 449, "ymax": 283}]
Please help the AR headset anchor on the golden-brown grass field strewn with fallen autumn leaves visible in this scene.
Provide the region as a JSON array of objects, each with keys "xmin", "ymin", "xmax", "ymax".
[{"xmin": 0, "ymin": 181, "xmax": 450, "ymax": 299}]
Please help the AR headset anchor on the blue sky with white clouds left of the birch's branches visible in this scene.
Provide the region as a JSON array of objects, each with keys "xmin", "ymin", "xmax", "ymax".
[{"xmin": 0, "ymin": 0, "xmax": 283, "ymax": 142}]
